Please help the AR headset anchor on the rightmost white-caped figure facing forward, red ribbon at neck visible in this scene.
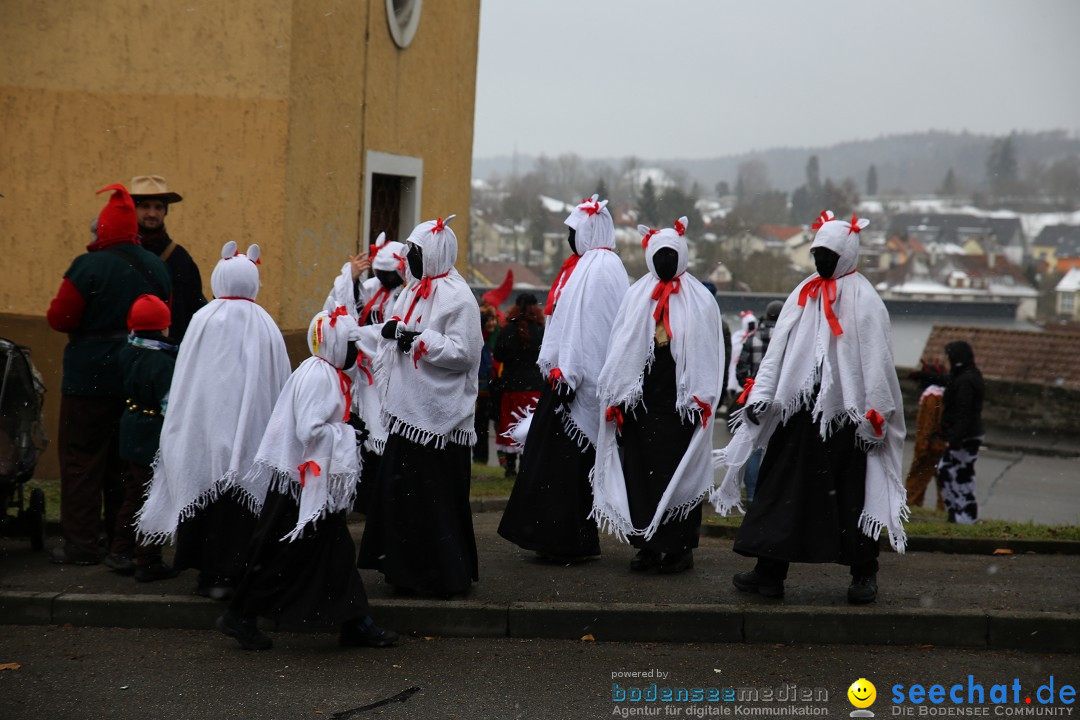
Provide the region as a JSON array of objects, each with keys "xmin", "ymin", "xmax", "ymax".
[{"xmin": 712, "ymin": 212, "xmax": 907, "ymax": 603}]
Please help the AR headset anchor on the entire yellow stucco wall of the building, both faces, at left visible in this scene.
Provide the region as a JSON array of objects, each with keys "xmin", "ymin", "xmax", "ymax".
[{"xmin": 0, "ymin": 0, "xmax": 480, "ymax": 476}]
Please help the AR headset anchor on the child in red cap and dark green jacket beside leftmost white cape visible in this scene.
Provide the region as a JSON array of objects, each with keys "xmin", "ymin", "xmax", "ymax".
[{"xmin": 105, "ymin": 295, "xmax": 177, "ymax": 583}]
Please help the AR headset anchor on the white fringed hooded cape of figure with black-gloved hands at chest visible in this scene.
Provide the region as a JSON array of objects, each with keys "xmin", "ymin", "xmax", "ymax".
[{"xmin": 375, "ymin": 218, "xmax": 484, "ymax": 448}]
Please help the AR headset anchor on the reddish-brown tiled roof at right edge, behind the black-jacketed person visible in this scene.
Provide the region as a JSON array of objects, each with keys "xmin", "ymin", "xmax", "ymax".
[{"xmin": 921, "ymin": 325, "xmax": 1080, "ymax": 388}]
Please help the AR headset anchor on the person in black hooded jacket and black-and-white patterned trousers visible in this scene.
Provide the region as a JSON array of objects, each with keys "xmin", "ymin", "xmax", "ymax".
[{"xmin": 937, "ymin": 340, "xmax": 984, "ymax": 525}]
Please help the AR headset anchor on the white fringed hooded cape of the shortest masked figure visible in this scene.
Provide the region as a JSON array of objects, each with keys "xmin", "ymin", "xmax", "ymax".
[{"xmin": 237, "ymin": 305, "xmax": 361, "ymax": 541}]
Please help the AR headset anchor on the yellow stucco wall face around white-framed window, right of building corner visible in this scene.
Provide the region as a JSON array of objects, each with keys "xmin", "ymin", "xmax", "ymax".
[{"xmin": 276, "ymin": 0, "xmax": 480, "ymax": 329}]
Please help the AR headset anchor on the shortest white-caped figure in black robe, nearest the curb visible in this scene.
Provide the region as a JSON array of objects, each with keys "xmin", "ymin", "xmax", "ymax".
[{"xmin": 218, "ymin": 305, "xmax": 396, "ymax": 650}]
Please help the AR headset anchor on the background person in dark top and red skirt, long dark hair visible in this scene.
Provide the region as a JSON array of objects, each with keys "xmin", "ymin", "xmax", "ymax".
[{"xmin": 494, "ymin": 293, "xmax": 545, "ymax": 477}]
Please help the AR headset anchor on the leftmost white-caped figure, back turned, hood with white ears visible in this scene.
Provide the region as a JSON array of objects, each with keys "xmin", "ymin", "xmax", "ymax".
[{"xmin": 138, "ymin": 241, "xmax": 291, "ymax": 599}]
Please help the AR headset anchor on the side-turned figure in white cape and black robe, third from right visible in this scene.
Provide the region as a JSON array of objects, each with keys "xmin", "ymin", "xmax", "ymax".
[{"xmin": 499, "ymin": 195, "xmax": 630, "ymax": 561}]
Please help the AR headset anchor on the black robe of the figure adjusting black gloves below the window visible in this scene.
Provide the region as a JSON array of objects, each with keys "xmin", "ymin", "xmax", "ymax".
[{"xmin": 356, "ymin": 433, "xmax": 480, "ymax": 597}]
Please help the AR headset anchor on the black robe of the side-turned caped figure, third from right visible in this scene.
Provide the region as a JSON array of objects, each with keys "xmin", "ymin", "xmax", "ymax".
[{"xmin": 499, "ymin": 389, "xmax": 600, "ymax": 558}]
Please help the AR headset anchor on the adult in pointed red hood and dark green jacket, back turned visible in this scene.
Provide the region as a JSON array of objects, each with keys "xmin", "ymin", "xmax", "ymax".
[{"xmin": 46, "ymin": 185, "xmax": 173, "ymax": 565}]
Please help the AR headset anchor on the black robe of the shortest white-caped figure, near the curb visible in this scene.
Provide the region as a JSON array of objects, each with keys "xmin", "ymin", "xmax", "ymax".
[{"xmin": 229, "ymin": 491, "xmax": 369, "ymax": 627}]
